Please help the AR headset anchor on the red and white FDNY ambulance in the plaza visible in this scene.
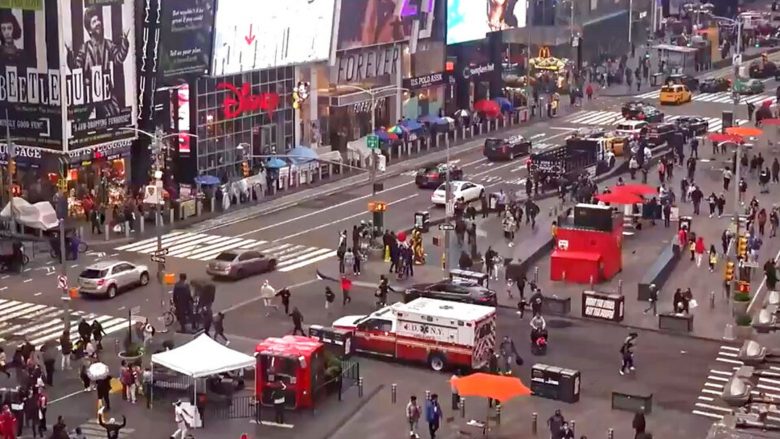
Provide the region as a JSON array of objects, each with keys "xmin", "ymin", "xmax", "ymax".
[{"xmin": 333, "ymin": 298, "xmax": 496, "ymax": 371}]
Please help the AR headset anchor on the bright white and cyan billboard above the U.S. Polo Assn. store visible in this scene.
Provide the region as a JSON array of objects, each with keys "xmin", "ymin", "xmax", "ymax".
[{"xmin": 447, "ymin": 0, "xmax": 528, "ymax": 44}]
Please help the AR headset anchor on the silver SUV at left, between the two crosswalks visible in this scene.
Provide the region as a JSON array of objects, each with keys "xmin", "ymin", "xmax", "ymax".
[{"xmin": 78, "ymin": 261, "xmax": 149, "ymax": 299}]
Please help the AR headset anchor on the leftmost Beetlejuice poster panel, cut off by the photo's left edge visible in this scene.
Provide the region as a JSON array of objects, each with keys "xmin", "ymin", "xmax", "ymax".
[{"xmin": 0, "ymin": 0, "xmax": 63, "ymax": 151}]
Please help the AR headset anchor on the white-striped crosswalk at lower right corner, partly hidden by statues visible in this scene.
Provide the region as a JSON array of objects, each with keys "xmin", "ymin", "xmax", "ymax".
[{"xmin": 692, "ymin": 345, "xmax": 780, "ymax": 423}]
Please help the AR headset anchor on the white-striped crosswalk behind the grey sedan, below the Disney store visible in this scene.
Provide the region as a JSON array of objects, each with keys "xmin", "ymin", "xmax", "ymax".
[{"xmin": 116, "ymin": 231, "xmax": 336, "ymax": 272}]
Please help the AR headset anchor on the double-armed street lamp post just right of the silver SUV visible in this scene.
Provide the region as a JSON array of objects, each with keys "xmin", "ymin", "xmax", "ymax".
[{"xmin": 122, "ymin": 128, "xmax": 198, "ymax": 333}]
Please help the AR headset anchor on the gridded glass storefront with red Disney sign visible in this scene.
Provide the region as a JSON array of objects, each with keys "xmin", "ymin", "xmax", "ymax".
[{"xmin": 195, "ymin": 67, "xmax": 297, "ymax": 181}]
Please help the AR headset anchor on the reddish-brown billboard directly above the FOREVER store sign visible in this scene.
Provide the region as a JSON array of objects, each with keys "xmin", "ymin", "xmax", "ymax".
[{"xmin": 336, "ymin": 0, "xmax": 436, "ymax": 50}]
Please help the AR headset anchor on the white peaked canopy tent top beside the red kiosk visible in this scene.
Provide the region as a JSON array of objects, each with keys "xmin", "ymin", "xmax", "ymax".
[{"xmin": 152, "ymin": 334, "xmax": 255, "ymax": 378}]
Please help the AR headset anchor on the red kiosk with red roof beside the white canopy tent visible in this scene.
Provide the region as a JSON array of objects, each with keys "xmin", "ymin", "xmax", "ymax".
[{"xmin": 255, "ymin": 335, "xmax": 325, "ymax": 410}]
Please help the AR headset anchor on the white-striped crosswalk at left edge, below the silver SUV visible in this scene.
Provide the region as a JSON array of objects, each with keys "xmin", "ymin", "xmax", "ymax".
[{"xmin": 0, "ymin": 299, "xmax": 127, "ymax": 347}]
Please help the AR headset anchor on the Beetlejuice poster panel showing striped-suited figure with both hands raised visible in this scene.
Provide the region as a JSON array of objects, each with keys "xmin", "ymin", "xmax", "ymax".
[{"xmin": 59, "ymin": 0, "xmax": 138, "ymax": 150}]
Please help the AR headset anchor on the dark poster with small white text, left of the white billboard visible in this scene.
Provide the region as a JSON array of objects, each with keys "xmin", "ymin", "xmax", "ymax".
[{"xmin": 160, "ymin": 0, "xmax": 214, "ymax": 80}]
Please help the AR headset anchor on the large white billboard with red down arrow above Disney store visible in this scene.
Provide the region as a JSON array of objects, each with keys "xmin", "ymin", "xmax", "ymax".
[{"xmin": 211, "ymin": 0, "xmax": 336, "ymax": 76}]
